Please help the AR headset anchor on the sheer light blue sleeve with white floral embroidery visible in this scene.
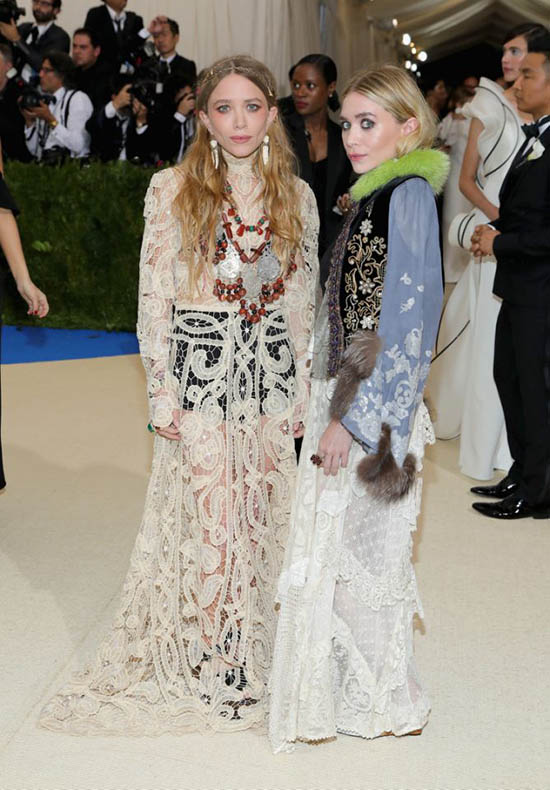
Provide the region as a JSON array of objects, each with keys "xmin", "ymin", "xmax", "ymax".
[{"xmin": 342, "ymin": 178, "xmax": 443, "ymax": 465}]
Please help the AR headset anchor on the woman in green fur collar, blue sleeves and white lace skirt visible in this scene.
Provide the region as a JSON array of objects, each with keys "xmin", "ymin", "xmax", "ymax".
[{"xmin": 270, "ymin": 66, "xmax": 448, "ymax": 751}]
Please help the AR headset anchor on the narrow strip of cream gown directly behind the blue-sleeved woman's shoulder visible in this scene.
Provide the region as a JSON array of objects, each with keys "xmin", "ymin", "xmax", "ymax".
[{"xmin": 438, "ymin": 113, "xmax": 473, "ymax": 283}]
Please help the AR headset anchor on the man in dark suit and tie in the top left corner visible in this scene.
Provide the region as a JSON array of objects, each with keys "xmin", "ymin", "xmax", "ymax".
[{"xmin": 0, "ymin": 0, "xmax": 71, "ymax": 83}]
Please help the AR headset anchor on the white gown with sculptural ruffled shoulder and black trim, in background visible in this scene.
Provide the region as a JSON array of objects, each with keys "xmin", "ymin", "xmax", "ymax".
[{"xmin": 428, "ymin": 77, "xmax": 524, "ymax": 480}]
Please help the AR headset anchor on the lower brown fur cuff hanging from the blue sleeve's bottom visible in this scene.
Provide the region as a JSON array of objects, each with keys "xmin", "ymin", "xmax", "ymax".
[{"xmin": 357, "ymin": 423, "xmax": 416, "ymax": 502}]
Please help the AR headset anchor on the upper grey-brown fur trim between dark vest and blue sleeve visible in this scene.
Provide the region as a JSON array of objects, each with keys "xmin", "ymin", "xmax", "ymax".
[{"xmin": 330, "ymin": 329, "xmax": 382, "ymax": 420}]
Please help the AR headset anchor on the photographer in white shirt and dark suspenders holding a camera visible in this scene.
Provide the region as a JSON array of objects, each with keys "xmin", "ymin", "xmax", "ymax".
[{"xmin": 19, "ymin": 51, "xmax": 93, "ymax": 164}]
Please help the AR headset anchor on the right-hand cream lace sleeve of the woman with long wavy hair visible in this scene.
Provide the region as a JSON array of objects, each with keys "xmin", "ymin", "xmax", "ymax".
[{"xmin": 286, "ymin": 181, "xmax": 319, "ymax": 422}]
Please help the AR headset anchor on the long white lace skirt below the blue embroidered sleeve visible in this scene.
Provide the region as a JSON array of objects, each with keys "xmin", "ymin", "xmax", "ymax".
[{"xmin": 269, "ymin": 381, "xmax": 434, "ymax": 752}]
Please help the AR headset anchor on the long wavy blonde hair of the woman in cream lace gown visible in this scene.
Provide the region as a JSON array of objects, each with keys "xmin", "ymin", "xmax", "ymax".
[{"xmin": 175, "ymin": 55, "xmax": 302, "ymax": 289}]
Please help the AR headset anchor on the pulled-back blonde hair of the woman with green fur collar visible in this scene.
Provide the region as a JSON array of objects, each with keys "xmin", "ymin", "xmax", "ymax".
[{"xmin": 343, "ymin": 65, "xmax": 437, "ymax": 157}]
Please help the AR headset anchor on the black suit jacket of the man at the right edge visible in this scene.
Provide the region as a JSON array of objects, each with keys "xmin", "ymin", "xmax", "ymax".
[{"xmin": 491, "ymin": 129, "xmax": 550, "ymax": 306}]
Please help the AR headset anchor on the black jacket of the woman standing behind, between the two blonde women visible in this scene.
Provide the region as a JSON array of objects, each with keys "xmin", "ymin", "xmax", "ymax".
[{"xmin": 283, "ymin": 113, "xmax": 352, "ymax": 266}]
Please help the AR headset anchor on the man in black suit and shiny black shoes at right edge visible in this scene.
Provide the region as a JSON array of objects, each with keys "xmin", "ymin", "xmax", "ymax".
[{"xmin": 472, "ymin": 31, "xmax": 550, "ymax": 519}]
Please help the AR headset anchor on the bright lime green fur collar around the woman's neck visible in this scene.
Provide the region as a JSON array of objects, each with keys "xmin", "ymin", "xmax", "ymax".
[{"xmin": 350, "ymin": 148, "xmax": 450, "ymax": 202}]
